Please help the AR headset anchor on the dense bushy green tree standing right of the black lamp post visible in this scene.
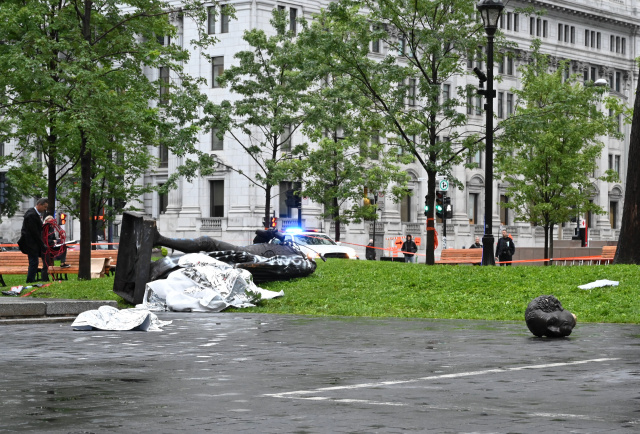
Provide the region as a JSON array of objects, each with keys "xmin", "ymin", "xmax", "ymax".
[{"xmin": 495, "ymin": 41, "xmax": 622, "ymax": 258}]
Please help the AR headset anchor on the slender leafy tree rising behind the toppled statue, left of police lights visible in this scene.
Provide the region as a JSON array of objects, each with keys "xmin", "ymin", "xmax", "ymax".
[{"xmin": 199, "ymin": 10, "xmax": 310, "ymax": 227}]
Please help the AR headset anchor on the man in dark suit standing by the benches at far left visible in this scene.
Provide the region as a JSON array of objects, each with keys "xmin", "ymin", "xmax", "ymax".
[{"xmin": 18, "ymin": 199, "xmax": 49, "ymax": 283}]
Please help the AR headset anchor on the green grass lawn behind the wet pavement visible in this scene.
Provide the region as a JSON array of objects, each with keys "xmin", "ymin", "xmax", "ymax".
[{"xmin": 4, "ymin": 259, "xmax": 640, "ymax": 323}]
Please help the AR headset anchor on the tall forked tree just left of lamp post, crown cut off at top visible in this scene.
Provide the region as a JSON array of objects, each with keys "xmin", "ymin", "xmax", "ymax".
[{"xmin": 296, "ymin": 0, "xmax": 503, "ymax": 264}]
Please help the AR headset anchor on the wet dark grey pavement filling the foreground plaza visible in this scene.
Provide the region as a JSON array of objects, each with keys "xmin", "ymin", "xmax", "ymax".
[{"xmin": 0, "ymin": 313, "xmax": 640, "ymax": 433}]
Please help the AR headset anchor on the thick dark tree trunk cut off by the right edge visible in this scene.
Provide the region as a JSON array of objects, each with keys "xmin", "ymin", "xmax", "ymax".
[{"xmin": 613, "ymin": 66, "xmax": 640, "ymax": 264}]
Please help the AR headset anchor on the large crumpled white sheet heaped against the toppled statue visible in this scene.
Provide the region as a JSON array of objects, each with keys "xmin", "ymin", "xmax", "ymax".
[{"xmin": 138, "ymin": 253, "xmax": 284, "ymax": 312}]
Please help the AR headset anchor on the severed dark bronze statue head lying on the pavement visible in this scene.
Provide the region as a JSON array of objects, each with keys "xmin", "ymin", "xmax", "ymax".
[{"xmin": 524, "ymin": 295, "xmax": 576, "ymax": 338}]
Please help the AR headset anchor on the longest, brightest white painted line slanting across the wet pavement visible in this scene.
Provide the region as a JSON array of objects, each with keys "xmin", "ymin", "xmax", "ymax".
[{"xmin": 264, "ymin": 358, "xmax": 619, "ymax": 399}]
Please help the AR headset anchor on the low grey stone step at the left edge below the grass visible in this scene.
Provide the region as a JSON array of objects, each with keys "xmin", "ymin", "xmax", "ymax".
[{"xmin": 0, "ymin": 295, "xmax": 118, "ymax": 325}]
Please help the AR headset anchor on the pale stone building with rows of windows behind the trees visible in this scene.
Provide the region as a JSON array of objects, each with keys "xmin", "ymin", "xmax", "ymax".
[{"xmin": 0, "ymin": 0, "xmax": 640, "ymax": 257}]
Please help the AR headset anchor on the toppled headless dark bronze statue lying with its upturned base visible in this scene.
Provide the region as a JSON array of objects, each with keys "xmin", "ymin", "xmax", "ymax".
[{"xmin": 113, "ymin": 212, "xmax": 316, "ymax": 304}]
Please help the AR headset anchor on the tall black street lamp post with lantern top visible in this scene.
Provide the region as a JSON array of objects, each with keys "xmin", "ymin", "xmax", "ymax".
[{"xmin": 476, "ymin": 0, "xmax": 504, "ymax": 265}]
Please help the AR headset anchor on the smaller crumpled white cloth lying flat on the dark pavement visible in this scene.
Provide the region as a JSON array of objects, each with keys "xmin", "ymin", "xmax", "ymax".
[{"xmin": 71, "ymin": 306, "xmax": 171, "ymax": 332}]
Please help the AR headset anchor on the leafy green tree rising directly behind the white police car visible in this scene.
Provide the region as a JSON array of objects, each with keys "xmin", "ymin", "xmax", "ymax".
[{"xmin": 294, "ymin": 50, "xmax": 407, "ymax": 241}]
